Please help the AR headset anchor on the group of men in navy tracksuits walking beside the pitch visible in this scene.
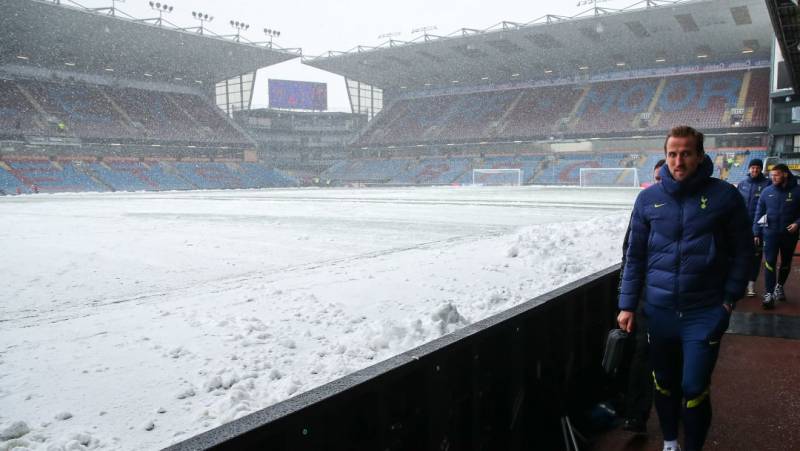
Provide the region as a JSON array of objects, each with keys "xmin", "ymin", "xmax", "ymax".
[{"xmin": 617, "ymin": 126, "xmax": 800, "ymax": 451}]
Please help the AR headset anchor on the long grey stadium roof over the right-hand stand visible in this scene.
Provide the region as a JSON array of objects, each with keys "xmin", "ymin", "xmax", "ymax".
[{"xmin": 303, "ymin": 0, "xmax": 772, "ymax": 89}]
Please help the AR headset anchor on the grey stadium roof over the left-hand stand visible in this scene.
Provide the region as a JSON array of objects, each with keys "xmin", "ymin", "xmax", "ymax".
[{"xmin": 0, "ymin": 0, "xmax": 301, "ymax": 83}]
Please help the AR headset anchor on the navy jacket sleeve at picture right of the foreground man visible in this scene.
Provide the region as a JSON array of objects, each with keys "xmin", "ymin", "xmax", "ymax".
[{"xmin": 724, "ymin": 189, "xmax": 762, "ymax": 302}]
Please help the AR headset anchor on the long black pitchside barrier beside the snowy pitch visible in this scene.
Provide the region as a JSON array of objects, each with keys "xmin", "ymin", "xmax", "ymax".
[{"xmin": 168, "ymin": 266, "xmax": 619, "ymax": 451}]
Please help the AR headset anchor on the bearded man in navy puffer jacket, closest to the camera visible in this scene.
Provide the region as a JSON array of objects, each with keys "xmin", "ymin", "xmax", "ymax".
[{"xmin": 617, "ymin": 126, "xmax": 754, "ymax": 451}]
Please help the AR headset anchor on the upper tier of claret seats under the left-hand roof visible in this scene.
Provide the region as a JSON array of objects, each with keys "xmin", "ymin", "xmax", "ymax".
[{"xmin": 0, "ymin": 79, "xmax": 248, "ymax": 144}]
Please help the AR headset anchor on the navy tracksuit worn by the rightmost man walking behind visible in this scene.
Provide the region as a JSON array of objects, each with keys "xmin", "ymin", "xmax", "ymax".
[{"xmin": 753, "ymin": 175, "xmax": 800, "ymax": 293}]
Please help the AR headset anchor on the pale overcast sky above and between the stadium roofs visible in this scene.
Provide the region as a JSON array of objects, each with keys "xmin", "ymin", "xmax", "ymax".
[{"xmin": 72, "ymin": 0, "xmax": 636, "ymax": 111}]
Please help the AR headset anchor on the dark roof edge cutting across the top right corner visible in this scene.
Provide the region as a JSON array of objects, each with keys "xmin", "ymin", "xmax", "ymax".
[{"xmin": 767, "ymin": 0, "xmax": 800, "ymax": 92}]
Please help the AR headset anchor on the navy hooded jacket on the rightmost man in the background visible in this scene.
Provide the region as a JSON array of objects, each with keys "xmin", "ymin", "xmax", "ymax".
[{"xmin": 753, "ymin": 174, "xmax": 800, "ymax": 237}]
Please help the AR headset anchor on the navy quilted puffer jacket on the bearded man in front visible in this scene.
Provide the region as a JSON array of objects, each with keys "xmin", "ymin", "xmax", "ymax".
[{"xmin": 619, "ymin": 156, "xmax": 754, "ymax": 311}]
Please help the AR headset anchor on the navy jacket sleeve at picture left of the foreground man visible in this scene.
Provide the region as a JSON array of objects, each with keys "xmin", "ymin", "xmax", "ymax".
[{"xmin": 619, "ymin": 194, "xmax": 650, "ymax": 311}]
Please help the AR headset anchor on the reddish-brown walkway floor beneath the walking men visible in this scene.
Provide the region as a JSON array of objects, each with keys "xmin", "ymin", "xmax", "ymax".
[{"xmin": 591, "ymin": 266, "xmax": 800, "ymax": 451}]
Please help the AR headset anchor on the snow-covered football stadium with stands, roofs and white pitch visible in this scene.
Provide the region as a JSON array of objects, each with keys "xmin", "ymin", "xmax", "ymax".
[{"xmin": 0, "ymin": 0, "xmax": 800, "ymax": 451}]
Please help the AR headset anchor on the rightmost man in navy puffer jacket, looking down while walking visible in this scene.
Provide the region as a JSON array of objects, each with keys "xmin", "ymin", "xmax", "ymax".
[{"xmin": 753, "ymin": 164, "xmax": 800, "ymax": 309}]
